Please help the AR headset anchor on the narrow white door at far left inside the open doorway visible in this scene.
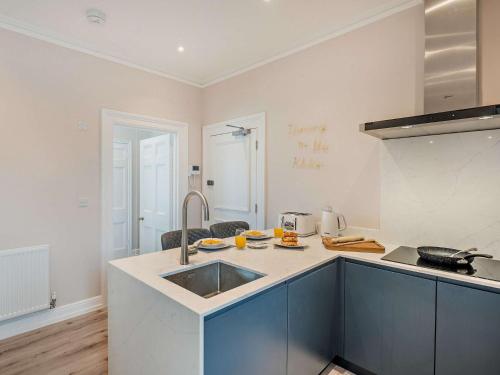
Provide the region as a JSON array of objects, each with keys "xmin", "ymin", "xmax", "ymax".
[{"xmin": 112, "ymin": 139, "xmax": 132, "ymax": 259}]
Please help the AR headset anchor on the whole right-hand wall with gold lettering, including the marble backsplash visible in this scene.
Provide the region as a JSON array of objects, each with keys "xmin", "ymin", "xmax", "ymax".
[{"xmin": 203, "ymin": 0, "xmax": 500, "ymax": 258}]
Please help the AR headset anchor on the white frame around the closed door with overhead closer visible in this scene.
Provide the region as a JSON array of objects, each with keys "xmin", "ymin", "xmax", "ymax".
[{"xmin": 201, "ymin": 112, "xmax": 266, "ymax": 228}]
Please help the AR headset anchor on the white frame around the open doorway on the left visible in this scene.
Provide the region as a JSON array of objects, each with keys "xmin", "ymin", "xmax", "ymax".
[{"xmin": 101, "ymin": 108, "xmax": 188, "ymax": 296}]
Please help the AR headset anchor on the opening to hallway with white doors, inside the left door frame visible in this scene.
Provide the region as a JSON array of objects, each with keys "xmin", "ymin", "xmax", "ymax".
[{"xmin": 113, "ymin": 125, "xmax": 177, "ymax": 258}]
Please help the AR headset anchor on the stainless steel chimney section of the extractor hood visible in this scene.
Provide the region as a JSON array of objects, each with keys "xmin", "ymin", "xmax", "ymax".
[{"xmin": 424, "ymin": 0, "xmax": 479, "ymax": 113}]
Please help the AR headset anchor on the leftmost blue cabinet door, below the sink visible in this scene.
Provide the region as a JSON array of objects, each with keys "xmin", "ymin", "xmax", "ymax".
[{"xmin": 204, "ymin": 285, "xmax": 287, "ymax": 375}]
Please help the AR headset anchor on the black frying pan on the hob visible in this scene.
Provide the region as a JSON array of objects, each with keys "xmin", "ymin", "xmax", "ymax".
[{"xmin": 417, "ymin": 246, "xmax": 493, "ymax": 267}]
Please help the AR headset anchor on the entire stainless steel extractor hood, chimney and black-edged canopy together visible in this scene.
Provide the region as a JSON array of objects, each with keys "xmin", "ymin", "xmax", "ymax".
[{"xmin": 360, "ymin": 0, "xmax": 500, "ymax": 139}]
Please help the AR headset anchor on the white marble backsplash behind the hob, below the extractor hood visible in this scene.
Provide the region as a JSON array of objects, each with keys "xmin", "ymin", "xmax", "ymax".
[{"xmin": 380, "ymin": 130, "xmax": 500, "ymax": 259}]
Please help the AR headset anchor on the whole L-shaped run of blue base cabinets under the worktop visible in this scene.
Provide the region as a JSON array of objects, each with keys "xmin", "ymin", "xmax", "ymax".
[{"xmin": 204, "ymin": 261, "xmax": 500, "ymax": 375}]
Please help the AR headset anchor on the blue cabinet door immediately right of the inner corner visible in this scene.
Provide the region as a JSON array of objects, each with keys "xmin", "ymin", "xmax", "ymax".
[{"xmin": 344, "ymin": 262, "xmax": 436, "ymax": 375}]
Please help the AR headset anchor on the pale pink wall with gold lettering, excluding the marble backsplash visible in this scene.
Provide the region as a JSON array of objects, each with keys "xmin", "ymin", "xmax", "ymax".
[{"xmin": 203, "ymin": 5, "xmax": 424, "ymax": 228}]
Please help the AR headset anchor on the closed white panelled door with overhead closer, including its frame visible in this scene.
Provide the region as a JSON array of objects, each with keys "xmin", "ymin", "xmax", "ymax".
[{"xmin": 203, "ymin": 114, "xmax": 265, "ymax": 229}]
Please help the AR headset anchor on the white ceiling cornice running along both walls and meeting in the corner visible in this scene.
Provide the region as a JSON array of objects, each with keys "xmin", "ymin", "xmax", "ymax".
[{"xmin": 0, "ymin": 0, "xmax": 422, "ymax": 88}]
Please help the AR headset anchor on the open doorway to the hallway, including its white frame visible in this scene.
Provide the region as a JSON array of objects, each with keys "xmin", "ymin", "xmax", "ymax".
[{"xmin": 101, "ymin": 109, "xmax": 188, "ymax": 285}]
